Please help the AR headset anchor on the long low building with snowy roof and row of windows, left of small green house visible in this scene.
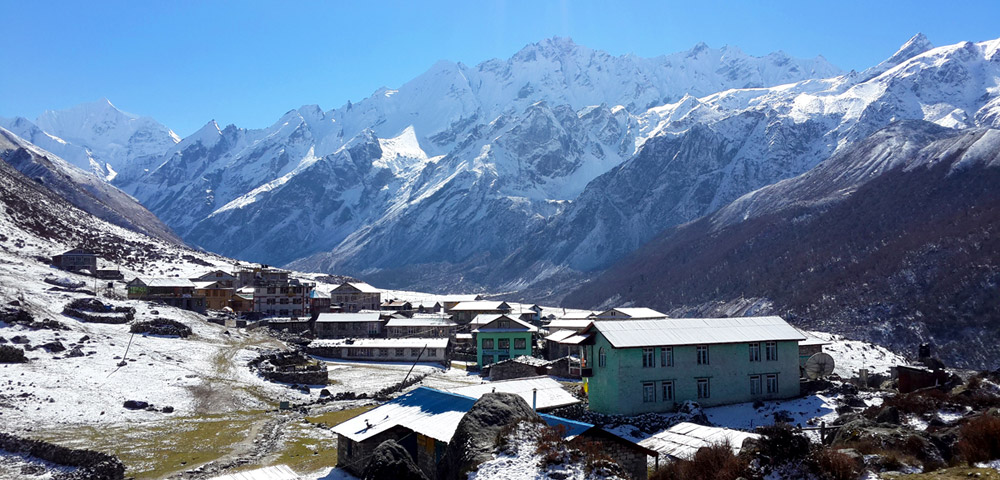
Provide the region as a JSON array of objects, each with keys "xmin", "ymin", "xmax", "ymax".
[{"xmin": 306, "ymin": 338, "xmax": 451, "ymax": 365}]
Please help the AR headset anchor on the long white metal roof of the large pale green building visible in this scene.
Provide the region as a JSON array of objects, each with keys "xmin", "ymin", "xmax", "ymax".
[{"xmin": 586, "ymin": 316, "xmax": 805, "ymax": 348}]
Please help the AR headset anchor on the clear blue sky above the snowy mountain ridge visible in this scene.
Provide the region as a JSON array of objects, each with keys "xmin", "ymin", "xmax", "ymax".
[{"xmin": 0, "ymin": 0, "xmax": 1000, "ymax": 136}]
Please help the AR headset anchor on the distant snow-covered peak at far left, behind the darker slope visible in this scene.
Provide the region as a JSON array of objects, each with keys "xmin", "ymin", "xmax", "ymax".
[{"xmin": 0, "ymin": 99, "xmax": 180, "ymax": 180}]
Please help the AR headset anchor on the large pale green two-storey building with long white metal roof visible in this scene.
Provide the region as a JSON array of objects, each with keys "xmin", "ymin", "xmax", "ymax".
[{"xmin": 582, "ymin": 317, "xmax": 805, "ymax": 415}]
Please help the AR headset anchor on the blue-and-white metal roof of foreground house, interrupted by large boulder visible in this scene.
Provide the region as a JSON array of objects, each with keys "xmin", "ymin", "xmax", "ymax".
[{"xmin": 332, "ymin": 387, "xmax": 593, "ymax": 443}]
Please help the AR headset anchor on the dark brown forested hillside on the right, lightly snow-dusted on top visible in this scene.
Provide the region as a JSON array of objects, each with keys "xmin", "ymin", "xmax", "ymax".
[{"xmin": 564, "ymin": 122, "xmax": 1000, "ymax": 368}]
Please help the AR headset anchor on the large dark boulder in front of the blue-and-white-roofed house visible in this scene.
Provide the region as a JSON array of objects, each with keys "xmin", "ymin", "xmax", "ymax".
[{"xmin": 437, "ymin": 393, "xmax": 541, "ymax": 480}]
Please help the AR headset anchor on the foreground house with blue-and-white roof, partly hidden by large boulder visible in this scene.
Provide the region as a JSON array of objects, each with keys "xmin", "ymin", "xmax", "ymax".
[{"xmin": 332, "ymin": 387, "xmax": 657, "ymax": 479}]
